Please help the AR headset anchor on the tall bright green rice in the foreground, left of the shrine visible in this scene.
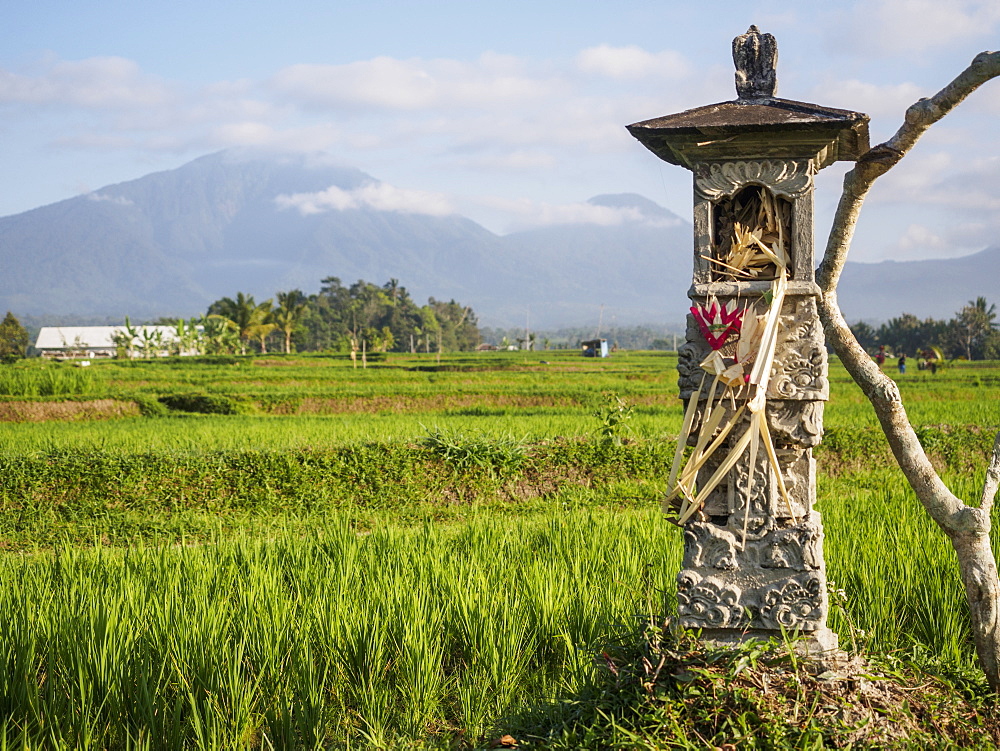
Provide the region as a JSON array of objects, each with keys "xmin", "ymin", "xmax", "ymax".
[{"xmin": 0, "ymin": 513, "xmax": 680, "ymax": 748}]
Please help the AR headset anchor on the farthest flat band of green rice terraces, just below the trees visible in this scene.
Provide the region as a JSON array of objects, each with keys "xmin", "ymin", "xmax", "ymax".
[{"xmin": 0, "ymin": 352, "xmax": 1000, "ymax": 452}]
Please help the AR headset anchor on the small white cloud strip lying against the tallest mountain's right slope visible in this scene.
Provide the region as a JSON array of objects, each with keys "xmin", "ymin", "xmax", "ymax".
[{"xmin": 275, "ymin": 182, "xmax": 455, "ymax": 216}]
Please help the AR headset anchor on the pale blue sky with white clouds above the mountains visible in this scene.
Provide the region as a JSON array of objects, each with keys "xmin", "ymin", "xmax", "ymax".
[{"xmin": 0, "ymin": 0, "xmax": 1000, "ymax": 261}]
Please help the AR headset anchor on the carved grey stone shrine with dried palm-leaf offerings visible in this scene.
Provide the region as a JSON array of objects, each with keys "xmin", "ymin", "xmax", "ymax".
[{"xmin": 628, "ymin": 26, "xmax": 868, "ymax": 650}]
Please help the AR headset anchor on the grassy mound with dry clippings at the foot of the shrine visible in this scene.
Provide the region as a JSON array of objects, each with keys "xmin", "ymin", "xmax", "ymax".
[{"xmin": 515, "ymin": 620, "xmax": 1000, "ymax": 751}]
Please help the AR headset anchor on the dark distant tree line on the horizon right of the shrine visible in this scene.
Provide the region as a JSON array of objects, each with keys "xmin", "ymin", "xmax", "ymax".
[{"xmin": 851, "ymin": 297, "xmax": 1000, "ymax": 360}]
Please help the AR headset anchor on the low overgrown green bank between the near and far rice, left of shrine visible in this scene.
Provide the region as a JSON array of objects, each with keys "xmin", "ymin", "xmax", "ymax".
[{"xmin": 0, "ymin": 434, "xmax": 670, "ymax": 546}]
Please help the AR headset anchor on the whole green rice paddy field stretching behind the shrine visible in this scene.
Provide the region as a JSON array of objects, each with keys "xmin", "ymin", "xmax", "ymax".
[{"xmin": 0, "ymin": 352, "xmax": 1000, "ymax": 748}]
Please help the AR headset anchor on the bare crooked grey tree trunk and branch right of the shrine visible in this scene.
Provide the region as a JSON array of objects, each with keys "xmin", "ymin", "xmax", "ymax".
[{"xmin": 816, "ymin": 52, "xmax": 1000, "ymax": 692}]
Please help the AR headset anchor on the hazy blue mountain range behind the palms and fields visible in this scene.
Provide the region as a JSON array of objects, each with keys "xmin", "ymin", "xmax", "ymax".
[{"xmin": 0, "ymin": 151, "xmax": 1000, "ymax": 328}]
